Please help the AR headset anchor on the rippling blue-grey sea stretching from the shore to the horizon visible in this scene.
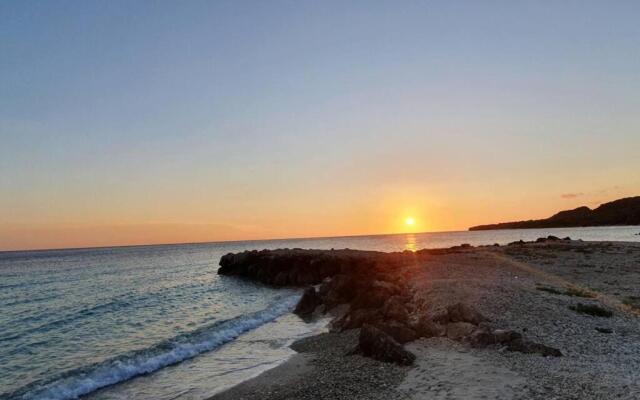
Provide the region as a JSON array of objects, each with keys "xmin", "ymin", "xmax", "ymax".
[{"xmin": 0, "ymin": 227, "xmax": 640, "ymax": 400}]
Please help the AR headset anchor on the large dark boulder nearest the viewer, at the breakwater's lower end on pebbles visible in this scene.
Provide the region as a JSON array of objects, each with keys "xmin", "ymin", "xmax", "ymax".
[{"xmin": 356, "ymin": 324, "xmax": 416, "ymax": 365}]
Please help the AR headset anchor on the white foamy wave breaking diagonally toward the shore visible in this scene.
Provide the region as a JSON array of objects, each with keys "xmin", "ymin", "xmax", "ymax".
[{"xmin": 18, "ymin": 295, "xmax": 299, "ymax": 400}]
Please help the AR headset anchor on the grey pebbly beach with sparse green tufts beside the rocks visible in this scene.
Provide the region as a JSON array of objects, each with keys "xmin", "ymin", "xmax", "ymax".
[{"xmin": 211, "ymin": 240, "xmax": 640, "ymax": 400}]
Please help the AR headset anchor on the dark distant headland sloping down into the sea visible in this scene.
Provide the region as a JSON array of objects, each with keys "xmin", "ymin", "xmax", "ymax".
[{"xmin": 469, "ymin": 196, "xmax": 640, "ymax": 231}]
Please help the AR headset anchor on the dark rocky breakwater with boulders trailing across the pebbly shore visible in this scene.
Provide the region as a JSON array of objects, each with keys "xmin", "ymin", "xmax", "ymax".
[{"xmin": 218, "ymin": 245, "xmax": 562, "ymax": 365}]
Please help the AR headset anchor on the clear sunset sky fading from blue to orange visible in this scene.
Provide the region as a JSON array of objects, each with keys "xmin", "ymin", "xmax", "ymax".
[{"xmin": 0, "ymin": 0, "xmax": 640, "ymax": 250}]
